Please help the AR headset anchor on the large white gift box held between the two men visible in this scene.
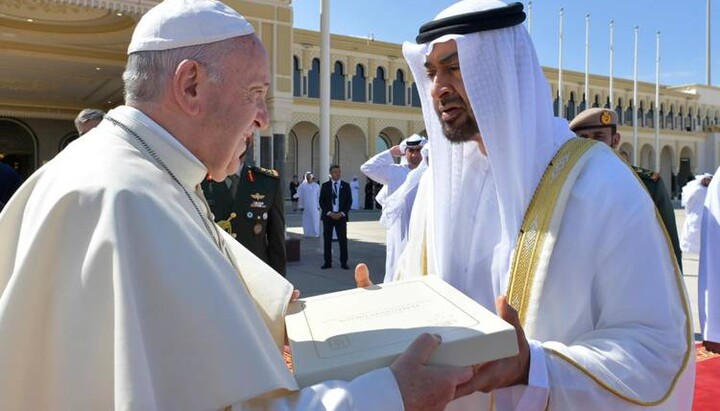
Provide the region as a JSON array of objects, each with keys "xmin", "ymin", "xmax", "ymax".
[{"xmin": 285, "ymin": 276, "xmax": 518, "ymax": 387}]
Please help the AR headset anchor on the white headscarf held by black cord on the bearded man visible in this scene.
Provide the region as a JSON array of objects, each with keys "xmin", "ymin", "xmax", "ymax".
[{"xmin": 403, "ymin": 0, "xmax": 573, "ymax": 295}]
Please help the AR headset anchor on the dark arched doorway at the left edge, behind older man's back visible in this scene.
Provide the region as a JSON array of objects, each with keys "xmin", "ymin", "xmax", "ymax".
[{"xmin": 0, "ymin": 118, "xmax": 37, "ymax": 179}]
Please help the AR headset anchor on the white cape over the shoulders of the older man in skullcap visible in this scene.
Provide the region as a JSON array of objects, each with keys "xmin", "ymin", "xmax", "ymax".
[{"xmin": 0, "ymin": 107, "xmax": 399, "ymax": 411}]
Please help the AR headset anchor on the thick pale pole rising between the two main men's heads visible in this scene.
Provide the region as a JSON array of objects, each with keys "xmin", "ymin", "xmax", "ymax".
[{"xmin": 316, "ymin": 0, "xmax": 330, "ymax": 184}]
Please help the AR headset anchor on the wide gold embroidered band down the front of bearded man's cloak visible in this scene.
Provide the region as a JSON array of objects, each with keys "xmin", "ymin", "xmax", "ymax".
[{"xmin": 507, "ymin": 138, "xmax": 596, "ymax": 326}]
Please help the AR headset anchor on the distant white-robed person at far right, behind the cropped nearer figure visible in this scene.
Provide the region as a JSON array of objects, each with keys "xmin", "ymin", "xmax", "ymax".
[{"xmin": 680, "ymin": 173, "xmax": 712, "ymax": 254}]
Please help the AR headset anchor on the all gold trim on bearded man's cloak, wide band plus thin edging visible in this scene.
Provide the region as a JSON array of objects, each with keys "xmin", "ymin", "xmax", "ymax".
[{"xmin": 507, "ymin": 139, "xmax": 693, "ymax": 407}]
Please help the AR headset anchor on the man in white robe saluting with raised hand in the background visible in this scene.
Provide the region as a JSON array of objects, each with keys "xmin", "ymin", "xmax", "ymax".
[{"xmin": 360, "ymin": 134, "xmax": 427, "ymax": 282}]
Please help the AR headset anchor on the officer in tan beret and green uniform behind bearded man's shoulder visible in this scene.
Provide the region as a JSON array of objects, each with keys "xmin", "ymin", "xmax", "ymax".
[{"xmin": 570, "ymin": 108, "xmax": 682, "ymax": 270}]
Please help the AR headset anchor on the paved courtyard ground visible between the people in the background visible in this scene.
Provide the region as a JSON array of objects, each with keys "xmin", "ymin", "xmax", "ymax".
[{"xmin": 286, "ymin": 209, "xmax": 699, "ymax": 338}]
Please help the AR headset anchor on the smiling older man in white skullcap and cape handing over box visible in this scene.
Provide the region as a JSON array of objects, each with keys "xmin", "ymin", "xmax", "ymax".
[{"xmin": 0, "ymin": 0, "xmax": 472, "ymax": 411}]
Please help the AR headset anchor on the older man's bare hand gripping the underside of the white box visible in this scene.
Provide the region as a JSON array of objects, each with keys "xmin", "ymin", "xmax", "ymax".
[{"xmin": 390, "ymin": 334, "xmax": 473, "ymax": 411}]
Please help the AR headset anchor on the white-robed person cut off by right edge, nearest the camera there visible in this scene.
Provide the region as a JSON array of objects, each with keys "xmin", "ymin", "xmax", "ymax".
[{"xmin": 698, "ymin": 168, "xmax": 720, "ymax": 354}]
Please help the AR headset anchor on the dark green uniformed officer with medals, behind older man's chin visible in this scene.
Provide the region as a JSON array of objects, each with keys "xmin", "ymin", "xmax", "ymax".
[{"xmin": 202, "ymin": 164, "xmax": 287, "ymax": 276}]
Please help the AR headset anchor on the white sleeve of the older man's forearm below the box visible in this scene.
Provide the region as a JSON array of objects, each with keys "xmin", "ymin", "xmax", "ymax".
[{"xmin": 238, "ymin": 368, "xmax": 403, "ymax": 411}]
